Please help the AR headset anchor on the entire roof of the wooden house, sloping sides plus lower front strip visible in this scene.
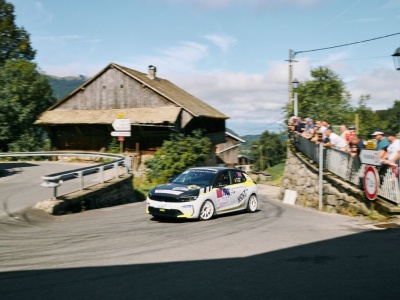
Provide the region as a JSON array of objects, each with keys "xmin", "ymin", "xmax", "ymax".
[{"xmin": 35, "ymin": 63, "xmax": 229, "ymax": 124}]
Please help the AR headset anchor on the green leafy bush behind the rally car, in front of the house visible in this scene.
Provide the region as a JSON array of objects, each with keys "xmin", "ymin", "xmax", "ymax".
[{"xmin": 145, "ymin": 130, "xmax": 211, "ymax": 182}]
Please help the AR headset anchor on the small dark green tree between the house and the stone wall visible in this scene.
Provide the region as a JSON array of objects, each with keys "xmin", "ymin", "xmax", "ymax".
[{"xmin": 253, "ymin": 131, "xmax": 286, "ymax": 171}]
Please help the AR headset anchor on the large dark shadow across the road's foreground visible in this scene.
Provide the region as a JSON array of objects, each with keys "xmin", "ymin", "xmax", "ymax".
[{"xmin": 0, "ymin": 228, "xmax": 400, "ymax": 300}]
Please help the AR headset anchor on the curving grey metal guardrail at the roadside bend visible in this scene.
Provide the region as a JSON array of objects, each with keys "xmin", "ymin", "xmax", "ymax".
[{"xmin": 0, "ymin": 151, "xmax": 131, "ymax": 199}]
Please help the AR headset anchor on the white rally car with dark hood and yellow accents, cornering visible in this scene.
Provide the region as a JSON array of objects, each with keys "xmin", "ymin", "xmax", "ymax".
[{"xmin": 146, "ymin": 167, "xmax": 258, "ymax": 220}]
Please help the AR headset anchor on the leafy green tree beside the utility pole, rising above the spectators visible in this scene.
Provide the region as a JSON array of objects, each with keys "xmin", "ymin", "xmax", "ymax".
[{"xmin": 288, "ymin": 67, "xmax": 353, "ymax": 124}]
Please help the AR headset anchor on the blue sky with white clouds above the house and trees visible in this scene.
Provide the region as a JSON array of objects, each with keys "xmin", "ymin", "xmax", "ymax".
[{"xmin": 6, "ymin": 0, "xmax": 400, "ymax": 136}]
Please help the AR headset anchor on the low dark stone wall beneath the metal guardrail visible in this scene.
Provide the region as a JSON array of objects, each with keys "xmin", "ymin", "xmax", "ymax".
[{"xmin": 35, "ymin": 174, "xmax": 136, "ymax": 215}]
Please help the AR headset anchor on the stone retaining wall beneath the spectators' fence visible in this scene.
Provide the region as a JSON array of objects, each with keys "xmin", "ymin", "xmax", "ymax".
[{"xmin": 279, "ymin": 147, "xmax": 396, "ymax": 219}]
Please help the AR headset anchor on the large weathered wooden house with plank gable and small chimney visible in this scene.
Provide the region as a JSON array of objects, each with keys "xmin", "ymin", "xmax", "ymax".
[{"xmin": 35, "ymin": 63, "xmax": 229, "ymax": 164}]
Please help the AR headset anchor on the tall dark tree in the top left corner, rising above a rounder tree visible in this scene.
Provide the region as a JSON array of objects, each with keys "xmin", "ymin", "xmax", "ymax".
[{"xmin": 0, "ymin": 0, "xmax": 36, "ymax": 66}]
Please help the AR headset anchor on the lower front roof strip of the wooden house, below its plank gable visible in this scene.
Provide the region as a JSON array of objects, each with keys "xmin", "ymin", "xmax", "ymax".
[{"xmin": 35, "ymin": 107, "xmax": 182, "ymax": 125}]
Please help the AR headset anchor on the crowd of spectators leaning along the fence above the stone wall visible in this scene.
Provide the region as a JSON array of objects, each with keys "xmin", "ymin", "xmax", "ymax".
[{"xmin": 289, "ymin": 116, "xmax": 400, "ymax": 166}]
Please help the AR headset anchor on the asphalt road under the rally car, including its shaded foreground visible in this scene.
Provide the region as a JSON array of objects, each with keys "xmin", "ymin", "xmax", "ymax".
[{"xmin": 0, "ymin": 186, "xmax": 400, "ymax": 300}]
